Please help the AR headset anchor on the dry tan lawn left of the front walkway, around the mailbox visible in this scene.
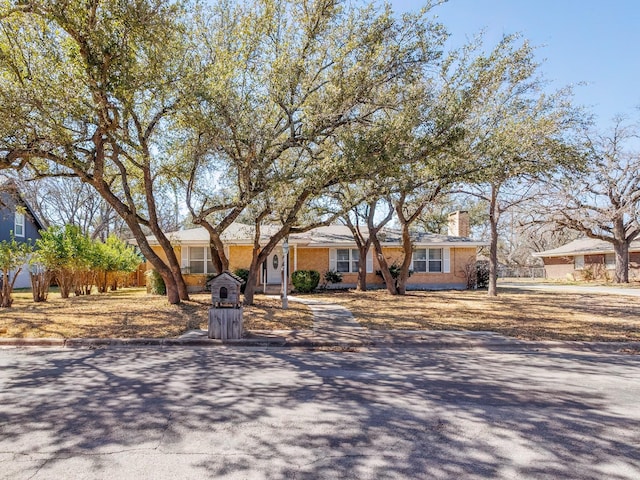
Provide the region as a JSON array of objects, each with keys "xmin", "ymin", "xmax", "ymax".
[{"xmin": 0, "ymin": 288, "xmax": 312, "ymax": 338}]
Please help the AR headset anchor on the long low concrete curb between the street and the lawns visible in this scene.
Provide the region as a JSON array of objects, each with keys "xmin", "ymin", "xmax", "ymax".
[{"xmin": 0, "ymin": 331, "xmax": 640, "ymax": 353}]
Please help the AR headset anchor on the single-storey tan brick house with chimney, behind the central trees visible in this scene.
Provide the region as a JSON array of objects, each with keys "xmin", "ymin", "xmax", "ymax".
[{"xmin": 147, "ymin": 212, "xmax": 486, "ymax": 291}]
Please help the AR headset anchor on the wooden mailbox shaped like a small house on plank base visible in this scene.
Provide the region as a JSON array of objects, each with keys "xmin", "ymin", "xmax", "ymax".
[{"xmin": 207, "ymin": 271, "xmax": 244, "ymax": 340}]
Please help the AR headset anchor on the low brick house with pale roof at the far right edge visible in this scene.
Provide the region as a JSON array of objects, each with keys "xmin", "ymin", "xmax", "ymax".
[{"xmin": 533, "ymin": 238, "xmax": 640, "ymax": 280}]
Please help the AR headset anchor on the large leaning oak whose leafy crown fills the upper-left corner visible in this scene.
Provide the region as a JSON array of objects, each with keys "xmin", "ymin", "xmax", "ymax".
[{"xmin": 0, "ymin": 0, "xmax": 196, "ymax": 303}]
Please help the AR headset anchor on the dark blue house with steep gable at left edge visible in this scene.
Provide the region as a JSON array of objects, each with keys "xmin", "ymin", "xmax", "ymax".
[{"xmin": 0, "ymin": 179, "xmax": 44, "ymax": 288}]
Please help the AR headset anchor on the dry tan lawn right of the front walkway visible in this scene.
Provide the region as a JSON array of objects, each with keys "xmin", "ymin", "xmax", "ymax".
[{"xmin": 308, "ymin": 289, "xmax": 640, "ymax": 342}]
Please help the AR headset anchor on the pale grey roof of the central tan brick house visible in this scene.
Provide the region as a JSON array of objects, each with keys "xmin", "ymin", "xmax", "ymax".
[{"xmin": 147, "ymin": 223, "xmax": 487, "ymax": 247}]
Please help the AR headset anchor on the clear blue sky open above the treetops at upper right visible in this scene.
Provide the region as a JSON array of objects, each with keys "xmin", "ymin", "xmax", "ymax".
[{"xmin": 391, "ymin": 0, "xmax": 640, "ymax": 129}]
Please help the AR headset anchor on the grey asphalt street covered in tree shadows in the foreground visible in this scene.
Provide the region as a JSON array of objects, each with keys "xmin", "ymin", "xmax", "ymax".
[{"xmin": 0, "ymin": 347, "xmax": 640, "ymax": 480}]
